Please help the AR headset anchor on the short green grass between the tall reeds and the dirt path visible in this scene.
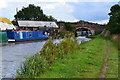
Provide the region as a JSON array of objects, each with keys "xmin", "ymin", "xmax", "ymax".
[{"xmin": 37, "ymin": 38, "xmax": 105, "ymax": 78}]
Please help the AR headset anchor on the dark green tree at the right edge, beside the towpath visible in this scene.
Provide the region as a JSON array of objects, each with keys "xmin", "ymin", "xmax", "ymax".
[{"xmin": 107, "ymin": 4, "xmax": 120, "ymax": 34}]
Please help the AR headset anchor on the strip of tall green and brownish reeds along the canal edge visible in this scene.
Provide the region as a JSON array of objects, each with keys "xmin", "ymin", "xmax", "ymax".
[{"xmin": 16, "ymin": 38, "xmax": 79, "ymax": 78}]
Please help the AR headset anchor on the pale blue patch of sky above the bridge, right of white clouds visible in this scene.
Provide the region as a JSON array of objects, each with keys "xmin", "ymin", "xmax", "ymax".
[{"xmin": 71, "ymin": 2, "xmax": 116, "ymax": 21}]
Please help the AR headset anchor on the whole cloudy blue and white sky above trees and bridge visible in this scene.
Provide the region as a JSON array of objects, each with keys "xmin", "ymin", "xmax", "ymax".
[{"xmin": 0, "ymin": 0, "xmax": 119, "ymax": 24}]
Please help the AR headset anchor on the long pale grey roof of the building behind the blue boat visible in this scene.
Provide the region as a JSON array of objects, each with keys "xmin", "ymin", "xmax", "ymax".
[{"xmin": 18, "ymin": 20, "xmax": 58, "ymax": 28}]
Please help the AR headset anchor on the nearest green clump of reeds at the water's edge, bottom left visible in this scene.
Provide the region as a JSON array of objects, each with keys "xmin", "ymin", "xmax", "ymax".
[{"xmin": 17, "ymin": 54, "xmax": 48, "ymax": 78}]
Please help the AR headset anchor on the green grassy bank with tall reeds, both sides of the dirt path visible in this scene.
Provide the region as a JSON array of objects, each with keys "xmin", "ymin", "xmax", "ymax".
[{"xmin": 17, "ymin": 36, "xmax": 118, "ymax": 78}]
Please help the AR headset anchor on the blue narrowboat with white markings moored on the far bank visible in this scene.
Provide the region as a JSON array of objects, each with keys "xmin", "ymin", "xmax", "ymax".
[{"xmin": 6, "ymin": 31, "xmax": 49, "ymax": 41}]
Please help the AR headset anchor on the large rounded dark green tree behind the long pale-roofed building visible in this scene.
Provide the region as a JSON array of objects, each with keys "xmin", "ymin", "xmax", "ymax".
[{"xmin": 14, "ymin": 4, "xmax": 56, "ymax": 21}]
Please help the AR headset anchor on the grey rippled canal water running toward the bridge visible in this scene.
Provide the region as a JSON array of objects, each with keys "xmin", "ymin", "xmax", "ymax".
[{"xmin": 0, "ymin": 37, "xmax": 90, "ymax": 78}]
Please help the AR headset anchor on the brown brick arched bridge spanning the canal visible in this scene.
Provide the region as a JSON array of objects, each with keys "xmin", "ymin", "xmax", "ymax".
[{"xmin": 58, "ymin": 22, "xmax": 105, "ymax": 35}]
